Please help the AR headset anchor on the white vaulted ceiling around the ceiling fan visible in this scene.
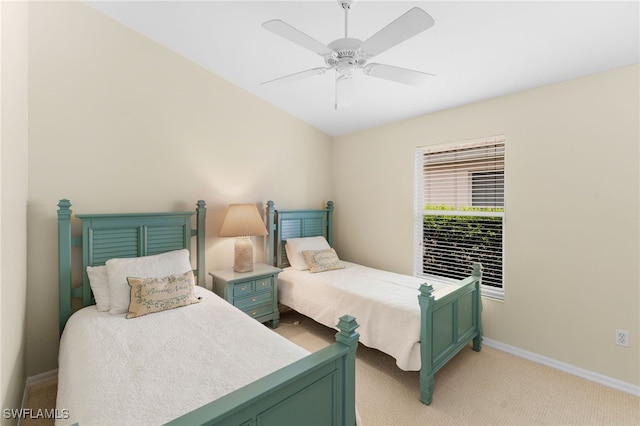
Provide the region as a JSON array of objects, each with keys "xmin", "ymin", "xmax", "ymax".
[{"xmin": 86, "ymin": 0, "xmax": 640, "ymax": 136}]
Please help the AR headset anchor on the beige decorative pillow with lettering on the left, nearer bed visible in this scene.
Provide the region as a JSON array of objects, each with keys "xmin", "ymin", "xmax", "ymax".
[{"xmin": 127, "ymin": 270, "xmax": 199, "ymax": 318}]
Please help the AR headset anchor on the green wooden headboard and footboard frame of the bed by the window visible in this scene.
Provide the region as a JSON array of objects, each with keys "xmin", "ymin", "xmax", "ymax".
[{"xmin": 265, "ymin": 201, "xmax": 482, "ymax": 405}]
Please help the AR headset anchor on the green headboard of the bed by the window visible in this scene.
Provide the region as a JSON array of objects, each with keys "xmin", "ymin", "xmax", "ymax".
[{"xmin": 265, "ymin": 201, "xmax": 333, "ymax": 268}]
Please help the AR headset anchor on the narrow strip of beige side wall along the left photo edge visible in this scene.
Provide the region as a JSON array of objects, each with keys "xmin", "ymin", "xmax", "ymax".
[{"xmin": 0, "ymin": 1, "xmax": 28, "ymax": 424}]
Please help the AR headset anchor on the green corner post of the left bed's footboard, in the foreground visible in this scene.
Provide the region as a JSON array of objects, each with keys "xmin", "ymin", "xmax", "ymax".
[{"xmin": 336, "ymin": 315, "xmax": 360, "ymax": 425}]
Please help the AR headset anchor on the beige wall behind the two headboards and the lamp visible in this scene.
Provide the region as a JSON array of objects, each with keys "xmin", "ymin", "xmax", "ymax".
[{"xmin": 27, "ymin": 2, "xmax": 331, "ymax": 375}]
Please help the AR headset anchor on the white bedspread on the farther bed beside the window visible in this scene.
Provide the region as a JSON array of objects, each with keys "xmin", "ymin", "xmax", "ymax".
[{"xmin": 278, "ymin": 261, "xmax": 449, "ymax": 371}]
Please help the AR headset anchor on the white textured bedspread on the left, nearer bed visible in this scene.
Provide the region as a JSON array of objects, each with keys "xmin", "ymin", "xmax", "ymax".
[{"xmin": 56, "ymin": 288, "xmax": 308, "ymax": 426}]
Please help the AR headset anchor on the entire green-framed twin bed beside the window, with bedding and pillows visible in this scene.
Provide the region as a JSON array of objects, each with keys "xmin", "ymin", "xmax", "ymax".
[{"xmin": 266, "ymin": 201, "xmax": 482, "ymax": 404}]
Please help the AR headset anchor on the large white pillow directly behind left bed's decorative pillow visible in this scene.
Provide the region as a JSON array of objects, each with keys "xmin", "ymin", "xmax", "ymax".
[{"xmin": 106, "ymin": 249, "xmax": 192, "ymax": 314}]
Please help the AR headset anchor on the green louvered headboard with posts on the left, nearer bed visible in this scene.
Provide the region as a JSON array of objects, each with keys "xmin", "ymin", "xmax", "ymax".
[{"xmin": 58, "ymin": 200, "xmax": 207, "ymax": 334}]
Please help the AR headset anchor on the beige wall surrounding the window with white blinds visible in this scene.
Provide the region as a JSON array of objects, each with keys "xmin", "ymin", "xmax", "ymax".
[{"xmin": 333, "ymin": 66, "xmax": 640, "ymax": 386}]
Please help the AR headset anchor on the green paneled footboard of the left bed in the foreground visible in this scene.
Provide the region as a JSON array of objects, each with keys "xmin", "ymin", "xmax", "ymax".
[{"xmin": 168, "ymin": 316, "xmax": 359, "ymax": 426}]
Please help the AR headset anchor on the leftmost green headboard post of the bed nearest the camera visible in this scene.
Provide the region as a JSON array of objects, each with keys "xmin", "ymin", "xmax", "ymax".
[{"xmin": 58, "ymin": 199, "xmax": 71, "ymax": 335}]
